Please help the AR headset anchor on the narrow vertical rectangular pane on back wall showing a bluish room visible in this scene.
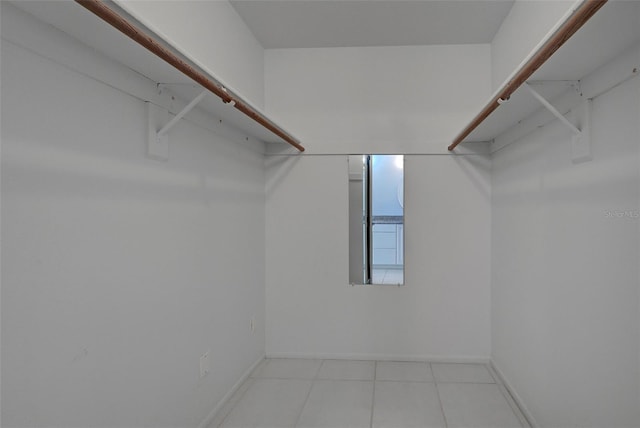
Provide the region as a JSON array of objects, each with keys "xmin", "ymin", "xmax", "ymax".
[{"xmin": 349, "ymin": 155, "xmax": 404, "ymax": 285}]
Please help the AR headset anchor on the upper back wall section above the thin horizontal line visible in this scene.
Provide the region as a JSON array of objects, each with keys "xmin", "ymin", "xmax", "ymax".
[{"xmin": 265, "ymin": 45, "xmax": 491, "ymax": 154}]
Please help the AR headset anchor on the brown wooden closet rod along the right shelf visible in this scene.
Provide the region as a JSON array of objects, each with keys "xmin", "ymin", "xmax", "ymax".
[{"xmin": 448, "ymin": 0, "xmax": 607, "ymax": 151}]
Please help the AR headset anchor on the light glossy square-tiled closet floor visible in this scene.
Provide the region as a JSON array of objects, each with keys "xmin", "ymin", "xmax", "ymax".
[{"xmin": 211, "ymin": 359, "xmax": 528, "ymax": 428}]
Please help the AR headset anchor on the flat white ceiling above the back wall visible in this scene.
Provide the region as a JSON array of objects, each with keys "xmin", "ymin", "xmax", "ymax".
[{"xmin": 231, "ymin": 0, "xmax": 513, "ymax": 49}]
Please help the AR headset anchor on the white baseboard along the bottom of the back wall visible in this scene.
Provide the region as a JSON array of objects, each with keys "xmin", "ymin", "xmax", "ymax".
[{"xmin": 267, "ymin": 352, "xmax": 491, "ymax": 364}]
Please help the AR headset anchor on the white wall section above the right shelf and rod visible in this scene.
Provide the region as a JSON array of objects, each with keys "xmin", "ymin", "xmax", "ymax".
[{"xmin": 491, "ymin": 0, "xmax": 576, "ymax": 90}]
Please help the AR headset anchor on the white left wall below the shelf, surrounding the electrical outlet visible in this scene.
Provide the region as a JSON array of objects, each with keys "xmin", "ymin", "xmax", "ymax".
[{"xmin": 1, "ymin": 4, "xmax": 265, "ymax": 428}]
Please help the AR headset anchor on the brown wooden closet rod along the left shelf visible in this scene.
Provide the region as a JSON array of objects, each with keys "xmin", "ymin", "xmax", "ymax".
[{"xmin": 75, "ymin": 0, "xmax": 304, "ymax": 152}]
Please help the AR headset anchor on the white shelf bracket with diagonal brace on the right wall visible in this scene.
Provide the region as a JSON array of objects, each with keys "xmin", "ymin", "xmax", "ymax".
[{"xmin": 524, "ymin": 82, "xmax": 593, "ymax": 163}]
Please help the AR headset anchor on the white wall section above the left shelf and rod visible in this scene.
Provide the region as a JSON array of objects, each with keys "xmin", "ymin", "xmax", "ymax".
[{"xmin": 117, "ymin": 0, "xmax": 264, "ymax": 108}]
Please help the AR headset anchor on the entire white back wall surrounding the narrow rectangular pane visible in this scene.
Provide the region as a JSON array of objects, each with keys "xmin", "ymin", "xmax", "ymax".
[{"xmin": 265, "ymin": 45, "xmax": 490, "ymax": 359}]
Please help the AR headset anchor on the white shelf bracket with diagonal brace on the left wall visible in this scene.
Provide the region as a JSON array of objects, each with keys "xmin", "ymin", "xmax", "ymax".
[{"xmin": 147, "ymin": 90, "xmax": 209, "ymax": 160}]
